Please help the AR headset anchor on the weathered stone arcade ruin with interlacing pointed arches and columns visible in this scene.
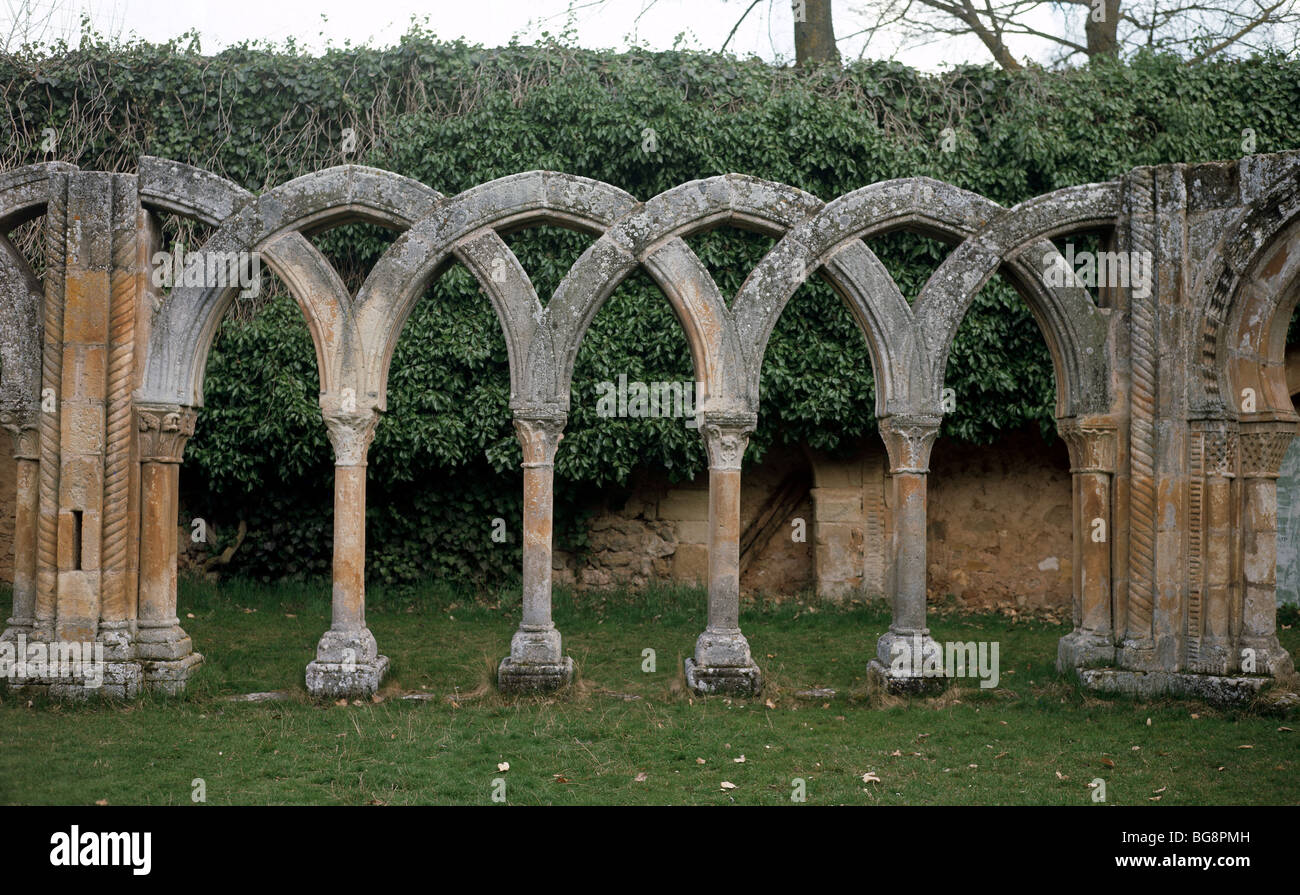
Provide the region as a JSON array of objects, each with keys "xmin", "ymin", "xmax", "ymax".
[{"xmin": 0, "ymin": 152, "xmax": 1300, "ymax": 701}]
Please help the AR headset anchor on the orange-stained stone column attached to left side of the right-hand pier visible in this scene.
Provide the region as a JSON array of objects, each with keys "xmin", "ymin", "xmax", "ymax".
[{"xmin": 1057, "ymin": 419, "xmax": 1115, "ymax": 671}]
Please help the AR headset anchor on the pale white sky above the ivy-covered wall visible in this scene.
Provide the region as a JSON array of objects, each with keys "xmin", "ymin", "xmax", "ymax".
[{"xmin": 0, "ymin": 0, "xmax": 1076, "ymax": 70}]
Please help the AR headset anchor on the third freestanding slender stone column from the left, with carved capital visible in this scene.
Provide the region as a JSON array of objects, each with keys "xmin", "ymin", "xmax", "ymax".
[{"xmin": 686, "ymin": 412, "xmax": 763, "ymax": 696}]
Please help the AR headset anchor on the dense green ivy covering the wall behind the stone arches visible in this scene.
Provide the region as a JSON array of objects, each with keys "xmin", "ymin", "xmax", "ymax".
[{"xmin": 0, "ymin": 30, "xmax": 1300, "ymax": 584}]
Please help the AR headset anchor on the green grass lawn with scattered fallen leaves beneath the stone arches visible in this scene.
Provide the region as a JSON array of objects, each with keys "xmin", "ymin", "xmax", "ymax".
[{"xmin": 0, "ymin": 581, "xmax": 1300, "ymax": 805}]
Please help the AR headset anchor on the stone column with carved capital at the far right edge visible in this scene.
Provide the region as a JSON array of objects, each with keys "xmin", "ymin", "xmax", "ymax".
[{"xmin": 1239, "ymin": 419, "xmax": 1296, "ymax": 678}]
